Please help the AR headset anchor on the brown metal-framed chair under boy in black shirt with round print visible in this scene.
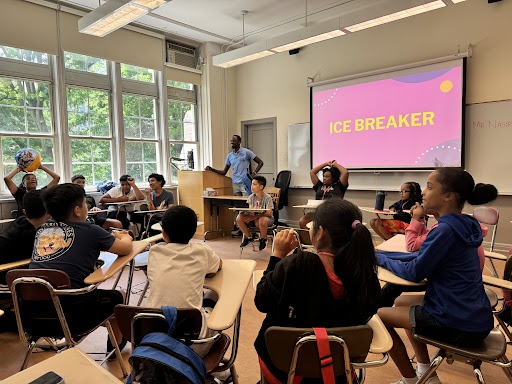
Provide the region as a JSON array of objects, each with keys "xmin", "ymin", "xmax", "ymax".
[{"xmin": 7, "ymin": 269, "xmax": 128, "ymax": 376}]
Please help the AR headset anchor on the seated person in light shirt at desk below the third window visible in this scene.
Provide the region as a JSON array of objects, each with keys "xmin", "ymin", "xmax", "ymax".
[{"xmin": 100, "ymin": 175, "xmax": 145, "ymax": 229}]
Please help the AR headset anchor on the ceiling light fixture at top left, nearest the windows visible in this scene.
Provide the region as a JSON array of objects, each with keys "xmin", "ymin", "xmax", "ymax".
[{"xmin": 78, "ymin": 0, "xmax": 171, "ymax": 37}]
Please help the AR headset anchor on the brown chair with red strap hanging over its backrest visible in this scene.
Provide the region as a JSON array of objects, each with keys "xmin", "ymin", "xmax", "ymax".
[{"xmin": 261, "ymin": 315, "xmax": 392, "ymax": 384}]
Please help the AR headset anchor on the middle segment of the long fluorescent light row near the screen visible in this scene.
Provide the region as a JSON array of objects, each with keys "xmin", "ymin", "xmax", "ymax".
[{"xmin": 268, "ymin": 17, "xmax": 345, "ymax": 52}]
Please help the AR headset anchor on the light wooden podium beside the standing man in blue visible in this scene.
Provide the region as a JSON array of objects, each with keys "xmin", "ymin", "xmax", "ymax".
[{"xmin": 178, "ymin": 171, "xmax": 233, "ymax": 239}]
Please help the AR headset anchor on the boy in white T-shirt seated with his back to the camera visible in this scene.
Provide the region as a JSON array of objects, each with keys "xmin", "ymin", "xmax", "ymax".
[{"xmin": 146, "ymin": 205, "xmax": 222, "ymax": 357}]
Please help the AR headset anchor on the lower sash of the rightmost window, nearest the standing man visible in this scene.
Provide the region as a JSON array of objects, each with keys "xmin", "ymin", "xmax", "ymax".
[{"xmin": 167, "ymin": 100, "xmax": 198, "ymax": 182}]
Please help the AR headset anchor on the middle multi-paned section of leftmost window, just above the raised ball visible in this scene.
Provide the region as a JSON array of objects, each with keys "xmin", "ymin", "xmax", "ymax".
[{"xmin": 0, "ymin": 78, "xmax": 53, "ymax": 134}]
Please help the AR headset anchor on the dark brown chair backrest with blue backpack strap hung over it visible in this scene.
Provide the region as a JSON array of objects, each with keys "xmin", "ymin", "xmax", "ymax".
[{"xmin": 114, "ymin": 304, "xmax": 203, "ymax": 347}]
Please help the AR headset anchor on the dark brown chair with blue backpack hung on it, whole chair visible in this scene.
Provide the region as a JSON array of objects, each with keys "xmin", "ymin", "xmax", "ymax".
[{"xmin": 115, "ymin": 305, "xmax": 231, "ymax": 382}]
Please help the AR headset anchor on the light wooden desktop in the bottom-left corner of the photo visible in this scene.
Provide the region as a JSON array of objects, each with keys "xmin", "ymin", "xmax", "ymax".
[{"xmin": 2, "ymin": 347, "xmax": 123, "ymax": 384}]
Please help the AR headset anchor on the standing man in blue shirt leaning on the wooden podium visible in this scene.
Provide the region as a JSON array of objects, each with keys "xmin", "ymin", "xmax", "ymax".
[{"xmin": 205, "ymin": 135, "xmax": 263, "ymax": 196}]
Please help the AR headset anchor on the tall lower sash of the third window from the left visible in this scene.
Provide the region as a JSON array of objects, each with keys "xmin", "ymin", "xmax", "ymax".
[{"xmin": 123, "ymin": 95, "xmax": 159, "ymax": 182}]
